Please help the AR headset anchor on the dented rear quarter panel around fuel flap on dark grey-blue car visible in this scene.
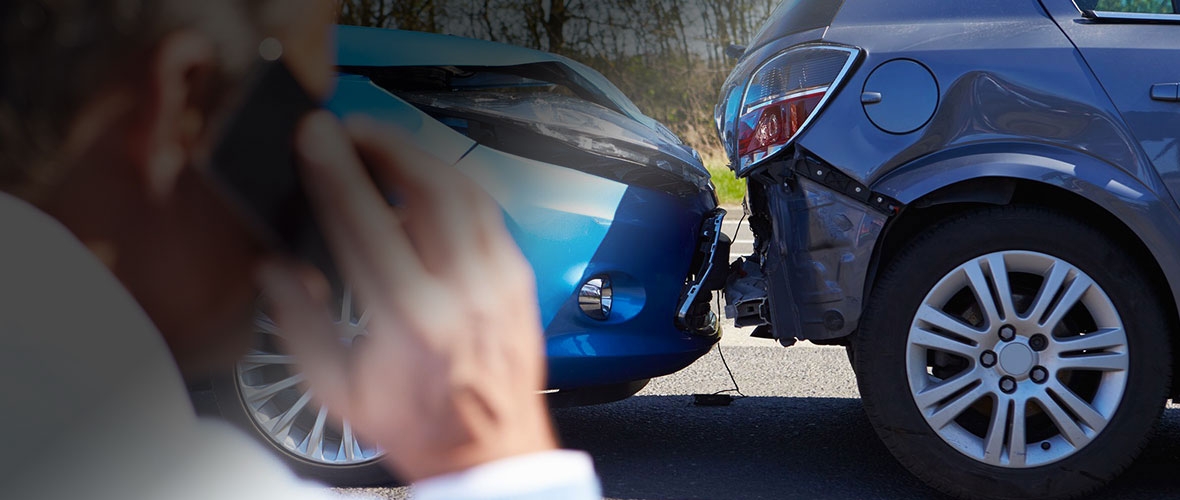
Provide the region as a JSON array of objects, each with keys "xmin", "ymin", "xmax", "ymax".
[{"xmin": 798, "ymin": 0, "xmax": 1149, "ymax": 185}]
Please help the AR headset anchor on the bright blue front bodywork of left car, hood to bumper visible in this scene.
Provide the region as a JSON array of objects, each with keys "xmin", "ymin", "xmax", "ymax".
[{"xmin": 329, "ymin": 27, "xmax": 720, "ymax": 390}]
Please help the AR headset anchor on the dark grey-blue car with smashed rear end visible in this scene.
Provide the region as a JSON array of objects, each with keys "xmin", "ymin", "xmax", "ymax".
[{"xmin": 716, "ymin": 0, "xmax": 1180, "ymax": 499}]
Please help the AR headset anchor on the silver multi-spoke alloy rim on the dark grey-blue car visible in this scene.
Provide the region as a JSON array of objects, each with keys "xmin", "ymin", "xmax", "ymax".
[{"xmin": 906, "ymin": 251, "xmax": 1130, "ymax": 468}]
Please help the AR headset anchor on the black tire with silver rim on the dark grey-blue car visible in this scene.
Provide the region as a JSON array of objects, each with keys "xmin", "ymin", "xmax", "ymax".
[{"xmin": 853, "ymin": 206, "xmax": 1171, "ymax": 499}]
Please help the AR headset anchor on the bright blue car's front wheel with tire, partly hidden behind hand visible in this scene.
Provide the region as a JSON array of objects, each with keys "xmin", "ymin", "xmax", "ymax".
[{"xmin": 211, "ymin": 297, "xmax": 396, "ymax": 487}]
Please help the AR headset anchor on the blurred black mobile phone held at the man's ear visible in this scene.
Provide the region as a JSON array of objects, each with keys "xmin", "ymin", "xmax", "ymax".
[{"xmin": 207, "ymin": 59, "xmax": 340, "ymax": 285}]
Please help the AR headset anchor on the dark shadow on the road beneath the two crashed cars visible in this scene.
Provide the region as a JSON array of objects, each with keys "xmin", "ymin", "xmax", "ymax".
[{"xmin": 555, "ymin": 395, "xmax": 1180, "ymax": 500}]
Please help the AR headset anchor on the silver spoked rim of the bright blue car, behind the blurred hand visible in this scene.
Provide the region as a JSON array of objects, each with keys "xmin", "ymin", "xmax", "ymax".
[{"xmin": 236, "ymin": 291, "xmax": 385, "ymax": 466}]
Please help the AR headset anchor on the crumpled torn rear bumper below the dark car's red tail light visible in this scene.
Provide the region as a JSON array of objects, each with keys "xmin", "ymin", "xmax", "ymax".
[{"xmin": 726, "ymin": 158, "xmax": 893, "ymax": 342}]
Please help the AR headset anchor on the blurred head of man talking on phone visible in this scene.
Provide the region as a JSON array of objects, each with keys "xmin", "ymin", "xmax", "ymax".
[{"xmin": 0, "ymin": 0, "xmax": 335, "ymax": 369}]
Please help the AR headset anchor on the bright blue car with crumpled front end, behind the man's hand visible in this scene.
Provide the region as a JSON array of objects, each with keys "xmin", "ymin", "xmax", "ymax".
[{"xmin": 198, "ymin": 27, "xmax": 728, "ymax": 486}]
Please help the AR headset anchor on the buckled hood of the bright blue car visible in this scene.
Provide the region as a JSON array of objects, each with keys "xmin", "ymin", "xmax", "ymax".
[{"xmin": 336, "ymin": 26, "xmax": 712, "ymax": 190}]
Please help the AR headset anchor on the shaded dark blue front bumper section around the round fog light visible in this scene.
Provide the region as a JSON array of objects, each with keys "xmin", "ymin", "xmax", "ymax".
[{"xmin": 545, "ymin": 186, "xmax": 728, "ymax": 389}]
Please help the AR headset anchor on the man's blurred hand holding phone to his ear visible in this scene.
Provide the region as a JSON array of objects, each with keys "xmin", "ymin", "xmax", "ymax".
[{"xmin": 260, "ymin": 112, "xmax": 556, "ymax": 481}]
